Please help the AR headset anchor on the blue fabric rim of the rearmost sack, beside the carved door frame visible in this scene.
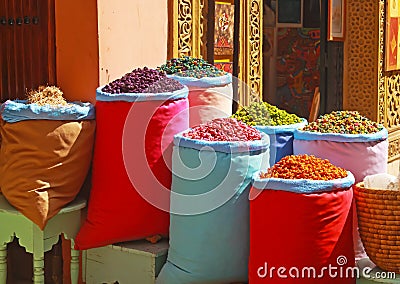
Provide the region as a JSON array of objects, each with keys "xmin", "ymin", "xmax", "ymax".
[{"xmin": 167, "ymin": 73, "xmax": 232, "ymax": 88}]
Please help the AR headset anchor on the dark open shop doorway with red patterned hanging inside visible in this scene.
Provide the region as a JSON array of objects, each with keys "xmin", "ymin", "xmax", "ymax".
[{"xmin": 263, "ymin": 0, "xmax": 343, "ymax": 118}]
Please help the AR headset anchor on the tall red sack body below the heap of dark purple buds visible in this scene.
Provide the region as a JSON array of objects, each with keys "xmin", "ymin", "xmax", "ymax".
[{"xmin": 75, "ymin": 98, "xmax": 189, "ymax": 250}]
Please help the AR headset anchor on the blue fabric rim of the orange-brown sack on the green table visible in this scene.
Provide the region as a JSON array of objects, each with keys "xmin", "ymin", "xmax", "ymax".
[{"xmin": 1, "ymin": 100, "xmax": 95, "ymax": 123}]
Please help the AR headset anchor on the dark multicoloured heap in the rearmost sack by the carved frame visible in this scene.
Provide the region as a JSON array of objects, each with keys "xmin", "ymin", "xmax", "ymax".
[{"xmin": 159, "ymin": 56, "xmax": 227, "ymax": 79}]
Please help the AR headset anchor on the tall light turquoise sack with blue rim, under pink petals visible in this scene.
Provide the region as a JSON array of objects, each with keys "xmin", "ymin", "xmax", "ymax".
[{"xmin": 156, "ymin": 133, "xmax": 269, "ymax": 284}]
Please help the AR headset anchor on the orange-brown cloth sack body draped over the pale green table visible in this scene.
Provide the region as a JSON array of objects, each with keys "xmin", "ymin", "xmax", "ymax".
[{"xmin": 0, "ymin": 119, "xmax": 96, "ymax": 230}]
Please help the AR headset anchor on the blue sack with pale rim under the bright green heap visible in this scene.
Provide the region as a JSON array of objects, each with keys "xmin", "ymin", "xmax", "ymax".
[{"xmin": 255, "ymin": 118, "xmax": 308, "ymax": 166}]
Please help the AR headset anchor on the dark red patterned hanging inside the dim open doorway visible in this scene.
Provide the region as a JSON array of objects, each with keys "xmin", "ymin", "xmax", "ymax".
[{"xmin": 273, "ymin": 28, "xmax": 320, "ymax": 117}]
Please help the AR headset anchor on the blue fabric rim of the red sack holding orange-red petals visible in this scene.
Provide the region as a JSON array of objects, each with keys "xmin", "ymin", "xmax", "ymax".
[{"xmin": 252, "ymin": 171, "xmax": 355, "ymax": 193}]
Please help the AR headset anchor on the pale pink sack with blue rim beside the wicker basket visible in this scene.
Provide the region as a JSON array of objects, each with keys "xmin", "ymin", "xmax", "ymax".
[{"xmin": 293, "ymin": 129, "xmax": 389, "ymax": 260}]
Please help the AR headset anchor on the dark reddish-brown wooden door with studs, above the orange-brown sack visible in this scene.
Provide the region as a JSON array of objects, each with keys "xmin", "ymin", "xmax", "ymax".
[{"xmin": 0, "ymin": 0, "xmax": 56, "ymax": 102}]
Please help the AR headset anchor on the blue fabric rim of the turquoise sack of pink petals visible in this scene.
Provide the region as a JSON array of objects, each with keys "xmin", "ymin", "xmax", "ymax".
[{"xmin": 174, "ymin": 129, "xmax": 270, "ymax": 153}]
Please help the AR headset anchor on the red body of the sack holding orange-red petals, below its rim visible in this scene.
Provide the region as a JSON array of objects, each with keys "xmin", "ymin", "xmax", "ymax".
[{"xmin": 249, "ymin": 187, "xmax": 356, "ymax": 284}]
